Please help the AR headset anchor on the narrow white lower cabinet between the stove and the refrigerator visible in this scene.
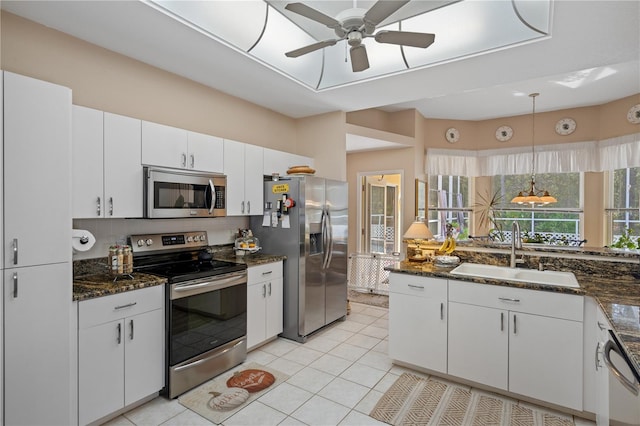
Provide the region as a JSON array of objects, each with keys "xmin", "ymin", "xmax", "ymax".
[{"xmin": 247, "ymin": 262, "xmax": 283, "ymax": 349}]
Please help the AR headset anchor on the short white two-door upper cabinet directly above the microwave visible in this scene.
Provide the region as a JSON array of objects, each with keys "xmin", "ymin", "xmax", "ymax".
[{"xmin": 142, "ymin": 121, "xmax": 223, "ymax": 173}]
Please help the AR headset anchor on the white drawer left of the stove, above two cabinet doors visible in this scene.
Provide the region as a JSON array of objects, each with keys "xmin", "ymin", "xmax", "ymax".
[{"xmin": 78, "ymin": 285, "xmax": 164, "ymax": 329}]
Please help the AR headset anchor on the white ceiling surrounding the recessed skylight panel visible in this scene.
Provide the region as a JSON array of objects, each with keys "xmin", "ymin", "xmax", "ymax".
[{"xmin": 1, "ymin": 0, "xmax": 640, "ymax": 120}]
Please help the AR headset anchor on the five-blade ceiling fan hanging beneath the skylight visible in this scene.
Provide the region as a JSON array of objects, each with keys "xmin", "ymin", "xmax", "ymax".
[{"xmin": 285, "ymin": 0, "xmax": 436, "ymax": 72}]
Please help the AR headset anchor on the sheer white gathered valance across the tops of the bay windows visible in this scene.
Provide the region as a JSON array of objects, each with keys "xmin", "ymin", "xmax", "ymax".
[{"xmin": 425, "ymin": 133, "xmax": 640, "ymax": 177}]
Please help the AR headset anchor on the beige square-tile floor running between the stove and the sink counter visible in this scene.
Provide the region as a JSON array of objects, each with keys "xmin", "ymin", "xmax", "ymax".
[{"xmin": 106, "ymin": 303, "xmax": 594, "ymax": 426}]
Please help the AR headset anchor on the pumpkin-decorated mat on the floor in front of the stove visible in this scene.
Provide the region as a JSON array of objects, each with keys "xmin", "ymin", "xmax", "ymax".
[{"xmin": 178, "ymin": 362, "xmax": 289, "ymax": 424}]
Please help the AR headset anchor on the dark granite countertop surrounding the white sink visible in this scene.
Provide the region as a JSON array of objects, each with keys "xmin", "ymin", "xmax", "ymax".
[{"xmin": 385, "ymin": 261, "xmax": 640, "ymax": 374}]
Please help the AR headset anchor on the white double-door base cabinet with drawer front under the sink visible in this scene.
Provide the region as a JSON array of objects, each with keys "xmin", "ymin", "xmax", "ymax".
[{"xmin": 448, "ymin": 280, "xmax": 584, "ymax": 411}]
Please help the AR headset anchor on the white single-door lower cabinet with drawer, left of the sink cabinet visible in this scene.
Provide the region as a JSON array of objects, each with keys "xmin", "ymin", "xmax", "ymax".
[{"xmin": 389, "ymin": 273, "xmax": 447, "ymax": 373}]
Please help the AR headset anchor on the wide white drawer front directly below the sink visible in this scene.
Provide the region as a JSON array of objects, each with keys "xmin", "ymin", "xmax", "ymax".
[{"xmin": 449, "ymin": 280, "xmax": 584, "ymax": 322}]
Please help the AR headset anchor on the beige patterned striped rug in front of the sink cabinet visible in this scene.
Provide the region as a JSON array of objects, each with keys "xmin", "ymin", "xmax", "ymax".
[{"xmin": 370, "ymin": 373, "xmax": 574, "ymax": 426}]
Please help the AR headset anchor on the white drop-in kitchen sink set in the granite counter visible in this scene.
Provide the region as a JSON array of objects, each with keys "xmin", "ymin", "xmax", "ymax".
[{"xmin": 450, "ymin": 263, "xmax": 580, "ymax": 288}]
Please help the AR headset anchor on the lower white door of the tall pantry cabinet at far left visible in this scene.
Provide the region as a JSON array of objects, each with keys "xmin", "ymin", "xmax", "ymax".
[{"xmin": 0, "ymin": 263, "xmax": 74, "ymax": 425}]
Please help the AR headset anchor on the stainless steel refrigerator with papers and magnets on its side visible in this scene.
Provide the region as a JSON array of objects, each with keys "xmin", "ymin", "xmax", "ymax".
[{"xmin": 251, "ymin": 176, "xmax": 348, "ymax": 342}]
